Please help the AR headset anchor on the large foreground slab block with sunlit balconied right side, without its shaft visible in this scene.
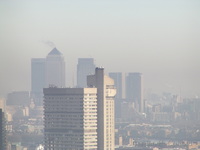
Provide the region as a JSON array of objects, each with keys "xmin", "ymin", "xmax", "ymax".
[{"xmin": 44, "ymin": 88, "xmax": 97, "ymax": 150}]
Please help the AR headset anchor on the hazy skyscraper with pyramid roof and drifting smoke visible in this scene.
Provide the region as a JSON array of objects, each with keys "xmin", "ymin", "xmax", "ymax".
[{"xmin": 46, "ymin": 48, "xmax": 65, "ymax": 87}]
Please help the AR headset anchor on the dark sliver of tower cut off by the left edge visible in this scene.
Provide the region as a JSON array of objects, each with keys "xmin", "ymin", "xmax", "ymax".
[{"xmin": 0, "ymin": 108, "xmax": 6, "ymax": 150}]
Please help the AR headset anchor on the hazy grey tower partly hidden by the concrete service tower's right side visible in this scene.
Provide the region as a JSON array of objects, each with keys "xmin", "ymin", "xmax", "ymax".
[{"xmin": 109, "ymin": 72, "xmax": 122, "ymax": 118}]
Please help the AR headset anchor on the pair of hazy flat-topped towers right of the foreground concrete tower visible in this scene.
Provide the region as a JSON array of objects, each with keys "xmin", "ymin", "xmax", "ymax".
[{"xmin": 109, "ymin": 72, "xmax": 145, "ymax": 121}]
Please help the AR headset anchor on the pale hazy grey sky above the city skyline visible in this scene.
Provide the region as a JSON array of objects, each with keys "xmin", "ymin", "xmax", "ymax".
[{"xmin": 0, "ymin": 0, "xmax": 200, "ymax": 97}]
